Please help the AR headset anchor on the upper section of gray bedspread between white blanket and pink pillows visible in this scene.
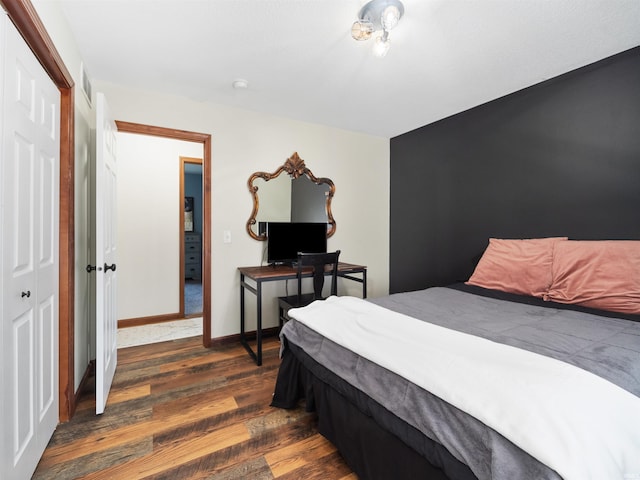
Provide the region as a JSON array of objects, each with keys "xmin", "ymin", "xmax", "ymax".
[{"xmin": 371, "ymin": 288, "xmax": 640, "ymax": 397}]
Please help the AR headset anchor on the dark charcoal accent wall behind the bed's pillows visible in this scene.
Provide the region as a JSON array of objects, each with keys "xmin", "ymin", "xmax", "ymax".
[{"xmin": 389, "ymin": 47, "xmax": 640, "ymax": 293}]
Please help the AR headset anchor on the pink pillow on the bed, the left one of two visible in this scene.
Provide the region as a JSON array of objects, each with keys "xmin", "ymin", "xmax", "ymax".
[{"xmin": 467, "ymin": 237, "xmax": 567, "ymax": 297}]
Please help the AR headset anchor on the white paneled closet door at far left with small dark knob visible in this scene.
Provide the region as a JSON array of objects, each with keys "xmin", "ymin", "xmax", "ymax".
[{"xmin": 0, "ymin": 12, "xmax": 60, "ymax": 479}]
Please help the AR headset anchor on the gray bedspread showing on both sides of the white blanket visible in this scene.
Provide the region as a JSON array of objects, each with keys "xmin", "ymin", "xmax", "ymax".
[{"xmin": 282, "ymin": 288, "xmax": 640, "ymax": 480}]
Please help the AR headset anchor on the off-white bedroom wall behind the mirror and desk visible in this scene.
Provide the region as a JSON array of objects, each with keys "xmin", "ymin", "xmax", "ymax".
[{"xmin": 96, "ymin": 82, "xmax": 389, "ymax": 337}]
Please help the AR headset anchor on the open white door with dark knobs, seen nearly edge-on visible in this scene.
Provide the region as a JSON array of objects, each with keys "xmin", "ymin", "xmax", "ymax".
[{"xmin": 95, "ymin": 93, "xmax": 118, "ymax": 414}]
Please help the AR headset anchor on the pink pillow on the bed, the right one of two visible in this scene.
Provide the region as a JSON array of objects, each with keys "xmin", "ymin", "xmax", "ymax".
[{"xmin": 544, "ymin": 240, "xmax": 640, "ymax": 314}]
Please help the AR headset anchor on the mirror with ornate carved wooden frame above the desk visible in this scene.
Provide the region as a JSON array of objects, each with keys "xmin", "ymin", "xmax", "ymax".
[{"xmin": 247, "ymin": 152, "xmax": 336, "ymax": 240}]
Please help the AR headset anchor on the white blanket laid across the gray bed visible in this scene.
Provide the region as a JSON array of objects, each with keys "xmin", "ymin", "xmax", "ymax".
[{"xmin": 290, "ymin": 297, "xmax": 640, "ymax": 480}]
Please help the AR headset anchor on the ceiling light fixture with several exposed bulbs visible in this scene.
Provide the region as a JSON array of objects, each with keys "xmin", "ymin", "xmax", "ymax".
[{"xmin": 351, "ymin": 0, "xmax": 404, "ymax": 57}]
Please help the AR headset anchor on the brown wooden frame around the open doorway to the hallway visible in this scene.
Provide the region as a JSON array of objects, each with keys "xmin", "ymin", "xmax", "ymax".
[{"xmin": 116, "ymin": 120, "xmax": 212, "ymax": 348}]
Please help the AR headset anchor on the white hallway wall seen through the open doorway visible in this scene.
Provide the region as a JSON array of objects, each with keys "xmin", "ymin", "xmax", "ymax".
[{"xmin": 117, "ymin": 133, "xmax": 203, "ymax": 320}]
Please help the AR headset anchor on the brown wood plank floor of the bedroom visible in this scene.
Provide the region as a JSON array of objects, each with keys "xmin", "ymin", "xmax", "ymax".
[{"xmin": 33, "ymin": 337, "xmax": 357, "ymax": 480}]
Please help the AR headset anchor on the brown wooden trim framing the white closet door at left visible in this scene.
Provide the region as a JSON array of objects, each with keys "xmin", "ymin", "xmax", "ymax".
[{"xmin": 0, "ymin": 0, "xmax": 77, "ymax": 422}]
